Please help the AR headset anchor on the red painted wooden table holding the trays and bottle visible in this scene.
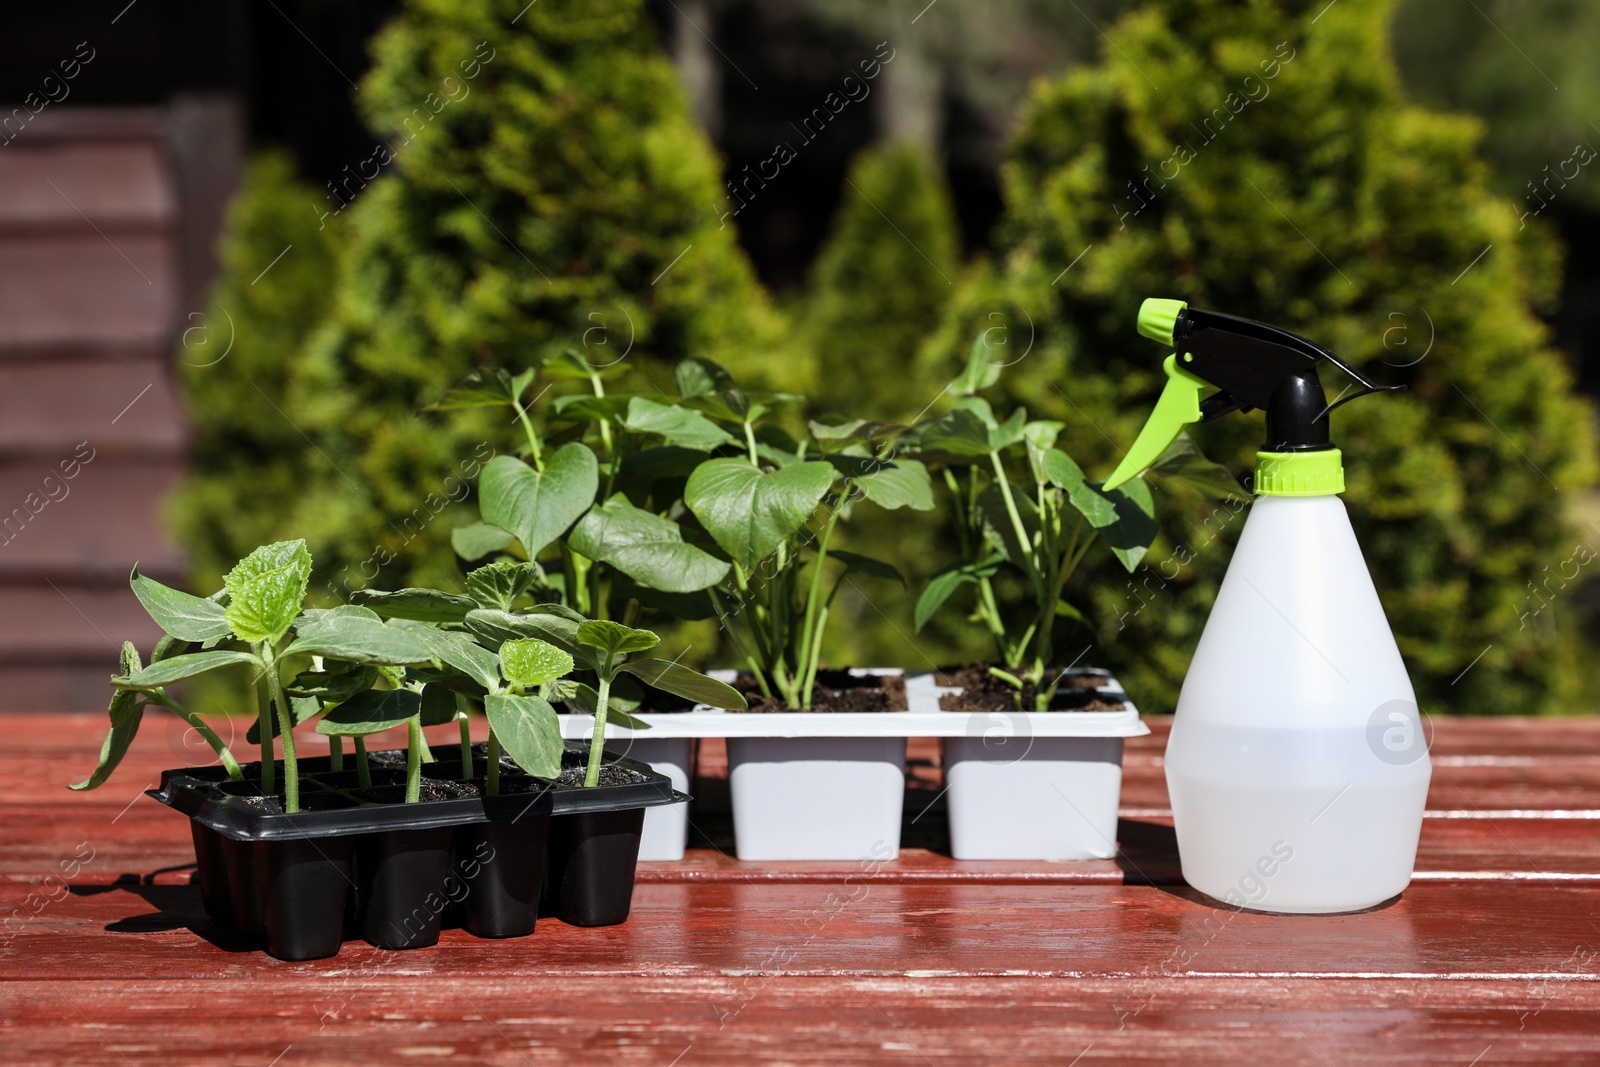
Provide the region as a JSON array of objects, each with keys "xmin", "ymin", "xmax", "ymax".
[{"xmin": 0, "ymin": 715, "xmax": 1600, "ymax": 1067}]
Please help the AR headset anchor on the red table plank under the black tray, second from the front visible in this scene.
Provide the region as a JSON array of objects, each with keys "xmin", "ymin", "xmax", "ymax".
[{"xmin": 0, "ymin": 881, "xmax": 1600, "ymax": 981}]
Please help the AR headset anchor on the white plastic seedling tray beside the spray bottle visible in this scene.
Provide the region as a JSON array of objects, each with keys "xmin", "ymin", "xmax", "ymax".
[{"xmin": 562, "ymin": 669, "xmax": 1150, "ymax": 861}]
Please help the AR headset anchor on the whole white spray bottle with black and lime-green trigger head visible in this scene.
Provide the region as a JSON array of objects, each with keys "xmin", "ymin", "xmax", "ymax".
[{"xmin": 1106, "ymin": 299, "xmax": 1432, "ymax": 913}]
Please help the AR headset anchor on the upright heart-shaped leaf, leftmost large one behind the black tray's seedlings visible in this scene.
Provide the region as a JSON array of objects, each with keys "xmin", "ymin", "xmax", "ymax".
[{"xmin": 478, "ymin": 442, "xmax": 600, "ymax": 560}]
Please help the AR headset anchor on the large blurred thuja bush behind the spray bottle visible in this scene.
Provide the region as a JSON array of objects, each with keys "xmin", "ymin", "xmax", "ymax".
[{"xmin": 938, "ymin": 0, "xmax": 1595, "ymax": 713}]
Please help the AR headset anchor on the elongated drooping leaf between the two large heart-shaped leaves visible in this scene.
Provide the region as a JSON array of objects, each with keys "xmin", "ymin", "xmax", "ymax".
[{"xmin": 568, "ymin": 494, "xmax": 728, "ymax": 593}]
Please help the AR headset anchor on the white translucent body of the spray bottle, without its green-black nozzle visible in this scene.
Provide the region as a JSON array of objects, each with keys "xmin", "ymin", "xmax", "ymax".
[{"xmin": 1165, "ymin": 494, "xmax": 1432, "ymax": 913}]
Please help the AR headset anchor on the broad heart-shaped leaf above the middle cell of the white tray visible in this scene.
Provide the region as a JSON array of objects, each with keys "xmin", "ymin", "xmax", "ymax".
[{"xmin": 683, "ymin": 459, "xmax": 834, "ymax": 571}]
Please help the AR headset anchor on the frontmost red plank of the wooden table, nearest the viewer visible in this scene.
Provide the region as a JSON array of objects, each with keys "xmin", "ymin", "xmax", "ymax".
[{"xmin": 0, "ymin": 973, "xmax": 1600, "ymax": 1067}]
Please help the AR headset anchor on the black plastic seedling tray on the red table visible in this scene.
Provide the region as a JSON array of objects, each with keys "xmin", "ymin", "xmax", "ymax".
[{"xmin": 149, "ymin": 744, "xmax": 688, "ymax": 960}]
